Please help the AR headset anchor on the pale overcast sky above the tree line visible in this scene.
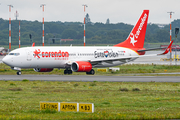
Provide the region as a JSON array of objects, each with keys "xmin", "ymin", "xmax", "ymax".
[{"xmin": 0, "ymin": 0, "xmax": 180, "ymax": 25}]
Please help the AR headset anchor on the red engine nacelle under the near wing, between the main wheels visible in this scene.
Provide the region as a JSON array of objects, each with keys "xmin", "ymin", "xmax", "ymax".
[{"xmin": 71, "ymin": 61, "xmax": 92, "ymax": 72}]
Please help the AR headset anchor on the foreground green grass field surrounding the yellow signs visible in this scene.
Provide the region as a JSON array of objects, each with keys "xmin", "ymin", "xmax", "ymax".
[{"xmin": 0, "ymin": 80, "xmax": 180, "ymax": 119}]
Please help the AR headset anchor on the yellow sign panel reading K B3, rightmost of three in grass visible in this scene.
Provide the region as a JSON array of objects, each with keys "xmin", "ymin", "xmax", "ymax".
[{"xmin": 79, "ymin": 103, "xmax": 94, "ymax": 113}]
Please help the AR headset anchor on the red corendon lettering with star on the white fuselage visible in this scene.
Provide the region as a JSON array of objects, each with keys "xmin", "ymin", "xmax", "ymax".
[{"xmin": 34, "ymin": 49, "xmax": 69, "ymax": 58}]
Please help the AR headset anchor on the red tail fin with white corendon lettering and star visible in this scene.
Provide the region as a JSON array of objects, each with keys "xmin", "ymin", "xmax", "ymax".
[{"xmin": 114, "ymin": 10, "xmax": 149, "ymax": 50}]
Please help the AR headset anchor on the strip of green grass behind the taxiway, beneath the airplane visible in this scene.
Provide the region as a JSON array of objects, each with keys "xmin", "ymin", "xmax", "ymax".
[{"xmin": 0, "ymin": 63, "xmax": 180, "ymax": 76}]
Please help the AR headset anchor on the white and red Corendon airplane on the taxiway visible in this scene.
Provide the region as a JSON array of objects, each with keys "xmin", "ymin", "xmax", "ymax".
[{"xmin": 2, "ymin": 10, "xmax": 173, "ymax": 75}]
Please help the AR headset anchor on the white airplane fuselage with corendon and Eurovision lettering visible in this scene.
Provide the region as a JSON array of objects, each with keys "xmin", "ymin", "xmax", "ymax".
[{"xmin": 3, "ymin": 46, "xmax": 139, "ymax": 68}]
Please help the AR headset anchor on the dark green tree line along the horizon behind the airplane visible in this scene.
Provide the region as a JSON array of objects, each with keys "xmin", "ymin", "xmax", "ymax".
[{"xmin": 0, "ymin": 18, "xmax": 180, "ymax": 46}]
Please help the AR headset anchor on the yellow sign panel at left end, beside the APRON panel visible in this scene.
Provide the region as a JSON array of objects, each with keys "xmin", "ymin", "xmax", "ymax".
[{"xmin": 40, "ymin": 101, "xmax": 60, "ymax": 111}]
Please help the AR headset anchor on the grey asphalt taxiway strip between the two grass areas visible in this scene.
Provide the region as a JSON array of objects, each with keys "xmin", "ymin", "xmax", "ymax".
[{"xmin": 0, "ymin": 75, "xmax": 180, "ymax": 82}]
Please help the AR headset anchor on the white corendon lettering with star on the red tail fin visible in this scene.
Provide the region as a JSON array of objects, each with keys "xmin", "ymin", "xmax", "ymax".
[{"xmin": 130, "ymin": 13, "xmax": 147, "ymax": 46}]
